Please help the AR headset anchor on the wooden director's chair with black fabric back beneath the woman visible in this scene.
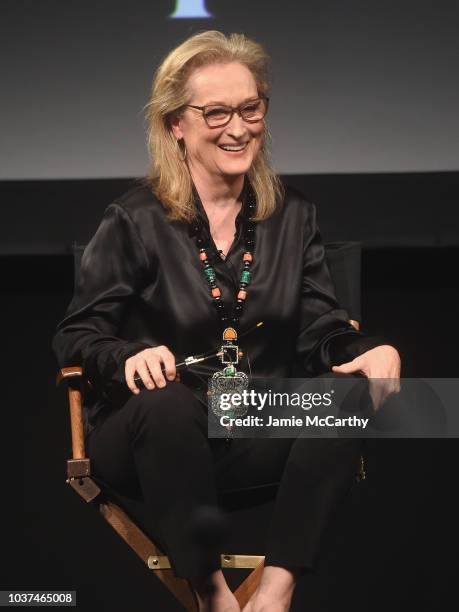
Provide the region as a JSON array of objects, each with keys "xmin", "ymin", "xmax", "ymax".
[{"xmin": 57, "ymin": 242, "xmax": 365, "ymax": 612}]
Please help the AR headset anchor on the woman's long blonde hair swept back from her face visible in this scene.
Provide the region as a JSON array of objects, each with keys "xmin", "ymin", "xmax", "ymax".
[{"xmin": 145, "ymin": 30, "xmax": 283, "ymax": 221}]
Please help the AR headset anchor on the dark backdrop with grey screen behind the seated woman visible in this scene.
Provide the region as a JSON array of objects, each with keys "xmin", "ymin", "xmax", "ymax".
[{"xmin": 0, "ymin": 0, "xmax": 459, "ymax": 612}]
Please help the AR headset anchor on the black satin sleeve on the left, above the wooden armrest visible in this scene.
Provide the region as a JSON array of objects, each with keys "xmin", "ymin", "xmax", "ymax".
[{"xmin": 52, "ymin": 203, "xmax": 151, "ymax": 389}]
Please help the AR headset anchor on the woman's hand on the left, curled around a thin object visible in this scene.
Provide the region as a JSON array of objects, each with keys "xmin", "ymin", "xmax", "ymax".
[{"xmin": 124, "ymin": 345, "xmax": 178, "ymax": 395}]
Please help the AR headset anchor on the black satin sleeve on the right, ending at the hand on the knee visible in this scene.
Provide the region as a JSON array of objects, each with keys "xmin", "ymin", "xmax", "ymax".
[{"xmin": 296, "ymin": 203, "xmax": 387, "ymax": 376}]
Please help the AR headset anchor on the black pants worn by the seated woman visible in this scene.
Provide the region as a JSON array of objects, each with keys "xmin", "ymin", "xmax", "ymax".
[{"xmin": 86, "ymin": 382, "xmax": 362, "ymax": 578}]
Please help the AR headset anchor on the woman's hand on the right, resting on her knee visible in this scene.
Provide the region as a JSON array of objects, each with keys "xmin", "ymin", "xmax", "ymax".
[{"xmin": 332, "ymin": 344, "xmax": 401, "ymax": 410}]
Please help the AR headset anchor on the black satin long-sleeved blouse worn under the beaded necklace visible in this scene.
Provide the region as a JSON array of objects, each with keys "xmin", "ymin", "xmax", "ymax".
[{"xmin": 53, "ymin": 181, "xmax": 382, "ymax": 431}]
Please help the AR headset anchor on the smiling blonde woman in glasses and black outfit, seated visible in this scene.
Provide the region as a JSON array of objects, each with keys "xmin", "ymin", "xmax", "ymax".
[{"xmin": 54, "ymin": 31, "xmax": 400, "ymax": 612}]
